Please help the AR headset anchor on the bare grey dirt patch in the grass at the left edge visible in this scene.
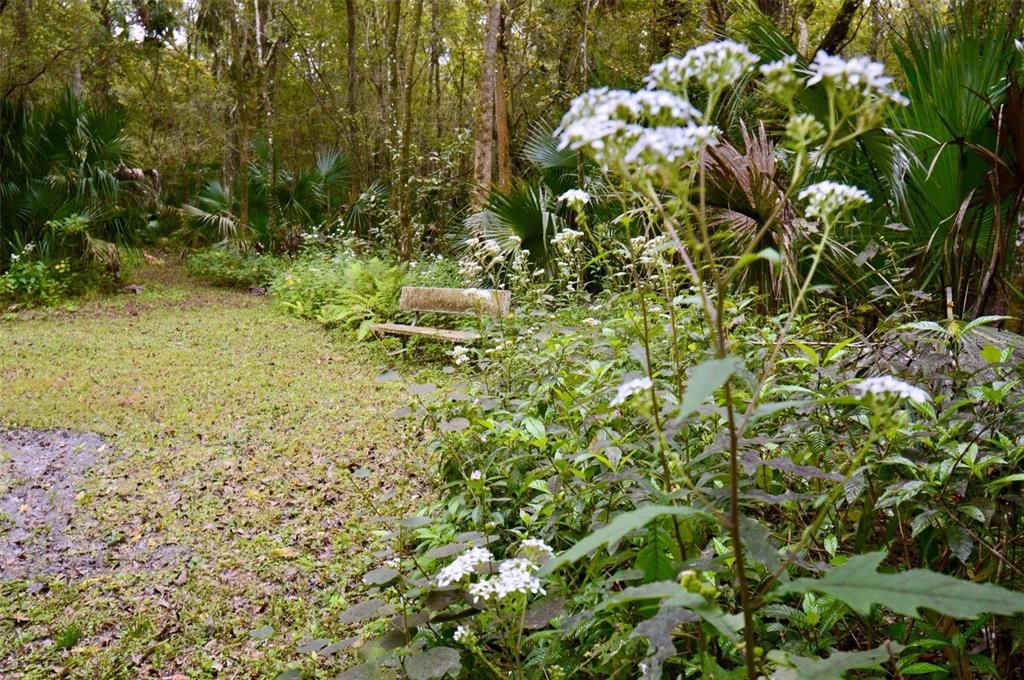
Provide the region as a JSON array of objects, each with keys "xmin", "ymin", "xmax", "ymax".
[{"xmin": 0, "ymin": 430, "xmax": 108, "ymax": 581}]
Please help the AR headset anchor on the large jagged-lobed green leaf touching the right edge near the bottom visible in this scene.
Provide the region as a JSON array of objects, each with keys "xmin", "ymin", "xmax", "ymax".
[{"xmin": 781, "ymin": 552, "xmax": 1024, "ymax": 619}]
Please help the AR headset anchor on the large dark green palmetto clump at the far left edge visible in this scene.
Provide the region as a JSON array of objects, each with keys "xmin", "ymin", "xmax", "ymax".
[{"xmin": 0, "ymin": 90, "xmax": 149, "ymax": 293}]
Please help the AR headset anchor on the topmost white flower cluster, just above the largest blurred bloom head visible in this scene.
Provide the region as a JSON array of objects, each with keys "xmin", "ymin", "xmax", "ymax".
[{"xmin": 644, "ymin": 40, "xmax": 759, "ymax": 92}]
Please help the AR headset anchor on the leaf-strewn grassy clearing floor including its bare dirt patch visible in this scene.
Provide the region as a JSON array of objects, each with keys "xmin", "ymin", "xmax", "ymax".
[{"xmin": 0, "ymin": 266, "xmax": 446, "ymax": 680}]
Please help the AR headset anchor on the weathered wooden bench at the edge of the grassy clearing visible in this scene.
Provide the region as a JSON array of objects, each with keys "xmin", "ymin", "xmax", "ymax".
[{"xmin": 370, "ymin": 287, "xmax": 512, "ymax": 343}]
